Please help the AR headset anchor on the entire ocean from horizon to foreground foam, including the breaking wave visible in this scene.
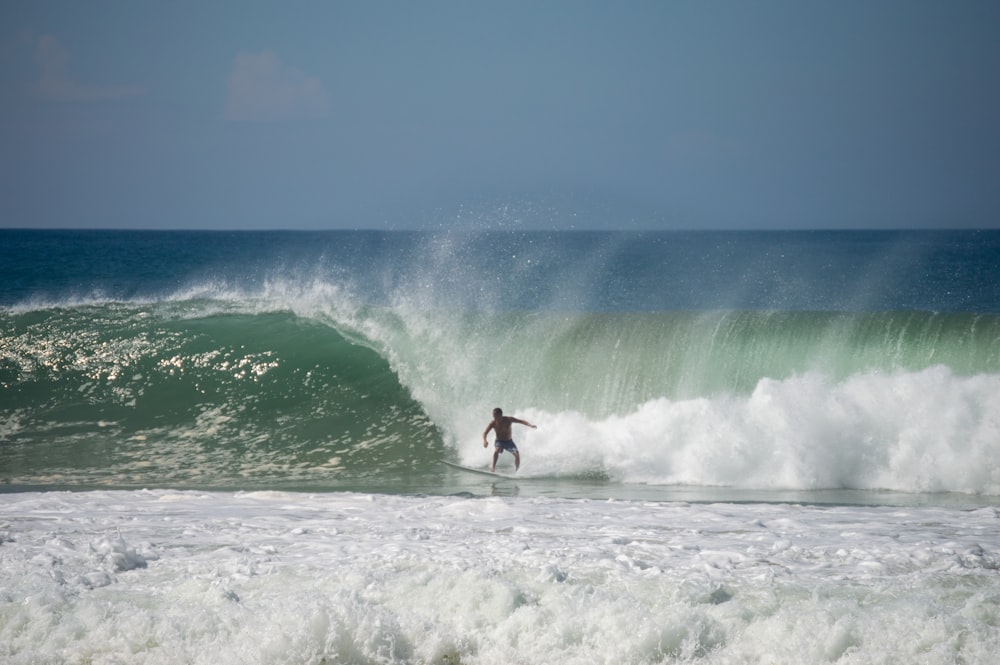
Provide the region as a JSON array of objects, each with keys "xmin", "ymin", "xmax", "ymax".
[{"xmin": 0, "ymin": 230, "xmax": 1000, "ymax": 665}]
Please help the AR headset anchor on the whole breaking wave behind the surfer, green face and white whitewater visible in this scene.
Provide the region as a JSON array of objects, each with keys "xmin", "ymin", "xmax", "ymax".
[{"xmin": 0, "ymin": 279, "xmax": 1000, "ymax": 494}]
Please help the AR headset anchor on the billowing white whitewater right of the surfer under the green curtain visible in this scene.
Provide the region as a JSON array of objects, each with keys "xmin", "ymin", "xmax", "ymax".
[{"xmin": 454, "ymin": 367, "xmax": 1000, "ymax": 495}]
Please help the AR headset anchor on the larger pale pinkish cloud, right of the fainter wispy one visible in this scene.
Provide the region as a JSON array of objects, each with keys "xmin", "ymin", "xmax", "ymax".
[{"xmin": 225, "ymin": 51, "xmax": 330, "ymax": 120}]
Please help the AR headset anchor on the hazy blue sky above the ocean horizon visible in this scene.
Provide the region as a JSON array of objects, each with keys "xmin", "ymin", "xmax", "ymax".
[{"xmin": 0, "ymin": 0, "xmax": 1000, "ymax": 229}]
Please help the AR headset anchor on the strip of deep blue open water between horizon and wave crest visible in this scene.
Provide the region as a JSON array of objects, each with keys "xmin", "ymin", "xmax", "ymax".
[{"xmin": 0, "ymin": 231, "xmax": 1000, "ymax": 313}]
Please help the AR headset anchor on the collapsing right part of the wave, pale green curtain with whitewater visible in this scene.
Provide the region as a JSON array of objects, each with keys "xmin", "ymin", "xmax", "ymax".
[{"xmin": 318, "ymin": 286, "xmax": 1000, "ymax": 494}]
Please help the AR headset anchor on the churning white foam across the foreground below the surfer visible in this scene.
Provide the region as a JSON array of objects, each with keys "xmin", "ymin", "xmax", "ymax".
[{"xmin": 0, "ymin": 491, "xmax": 1000, "ymax": 665}]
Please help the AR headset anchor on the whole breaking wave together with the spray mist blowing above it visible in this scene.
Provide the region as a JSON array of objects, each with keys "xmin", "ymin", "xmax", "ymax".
[{"xmin": 0, "ymin": 228, "xmax": 1000, "ymax": 494}]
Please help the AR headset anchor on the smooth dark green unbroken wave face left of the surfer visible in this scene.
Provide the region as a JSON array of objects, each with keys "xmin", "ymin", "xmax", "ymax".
[{"xmin": 0, "ymin": 303, "xmax": 442, "ymax": 487}]
